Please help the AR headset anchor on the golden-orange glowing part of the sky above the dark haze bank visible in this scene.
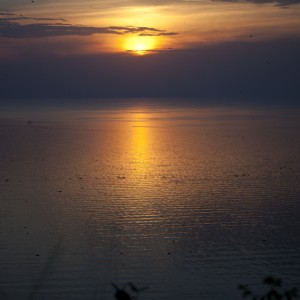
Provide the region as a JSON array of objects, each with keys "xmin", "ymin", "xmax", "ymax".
[{"xmin": 0, "ymin": 0, "xmax": 300, "ymax": 55}]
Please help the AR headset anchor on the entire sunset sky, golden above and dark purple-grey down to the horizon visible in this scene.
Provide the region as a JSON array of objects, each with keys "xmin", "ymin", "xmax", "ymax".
[{"xmin": 0, "ymin": 0, "xmax": 300, "ymax": 105}]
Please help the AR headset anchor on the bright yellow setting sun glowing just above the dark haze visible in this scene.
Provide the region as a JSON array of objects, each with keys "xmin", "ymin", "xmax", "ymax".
[{"xmin": 122, "ymin": 36, "xmax": 158, "ymax": 55}]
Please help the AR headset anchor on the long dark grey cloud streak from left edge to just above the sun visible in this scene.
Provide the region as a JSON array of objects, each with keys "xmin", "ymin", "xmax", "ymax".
[{"xmin": 0, "ymin": 12, "xmax": 176, "ymax": 39}]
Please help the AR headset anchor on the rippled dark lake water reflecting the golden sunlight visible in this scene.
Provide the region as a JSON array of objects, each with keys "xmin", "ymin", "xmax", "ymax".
[{"xmin": 0, "ymin": 104, "xmax": 300, "ymax": 300}]
